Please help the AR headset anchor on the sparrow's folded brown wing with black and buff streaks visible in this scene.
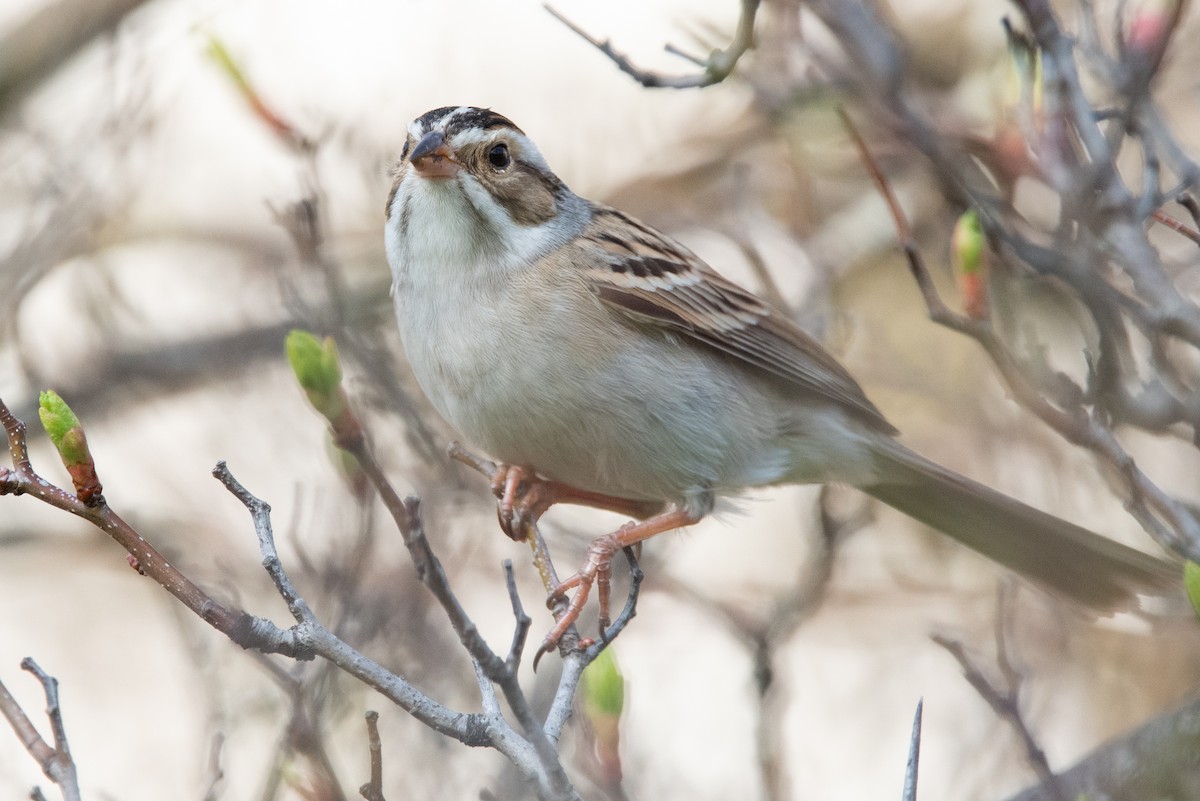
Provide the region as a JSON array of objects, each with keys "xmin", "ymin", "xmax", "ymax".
[{"xmin": 583, "ymin": 205, "xmax": 895, "ymax": 433}]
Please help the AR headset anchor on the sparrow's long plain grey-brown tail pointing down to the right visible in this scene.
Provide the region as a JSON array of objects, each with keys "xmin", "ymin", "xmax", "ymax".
[{"xmin": 862, "ymin": 442, "xmax": 1182, "ymax": 612}]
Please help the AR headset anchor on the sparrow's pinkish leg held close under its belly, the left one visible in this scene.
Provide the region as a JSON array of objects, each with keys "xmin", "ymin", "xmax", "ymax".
[{"xmin": 491, "ymin": 464, "xmax": 662, "ymax": 542}]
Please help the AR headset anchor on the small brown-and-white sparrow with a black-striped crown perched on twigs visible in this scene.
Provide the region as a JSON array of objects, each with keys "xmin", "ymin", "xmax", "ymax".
[{"xmin": 384, "ymin": 106, "xmax": 1178, "ymax": 656}]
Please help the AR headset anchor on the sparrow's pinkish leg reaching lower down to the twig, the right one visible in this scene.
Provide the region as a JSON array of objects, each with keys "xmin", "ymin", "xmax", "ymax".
[{"xmin": 538, "ymin": 507, "xmax": 703, "ymax": 657}]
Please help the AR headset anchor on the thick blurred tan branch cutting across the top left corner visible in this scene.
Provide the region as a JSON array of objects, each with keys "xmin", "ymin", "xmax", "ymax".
[{"xmin": 0, "ymin": 0, "xmax": 153, "ymax": 122}]
